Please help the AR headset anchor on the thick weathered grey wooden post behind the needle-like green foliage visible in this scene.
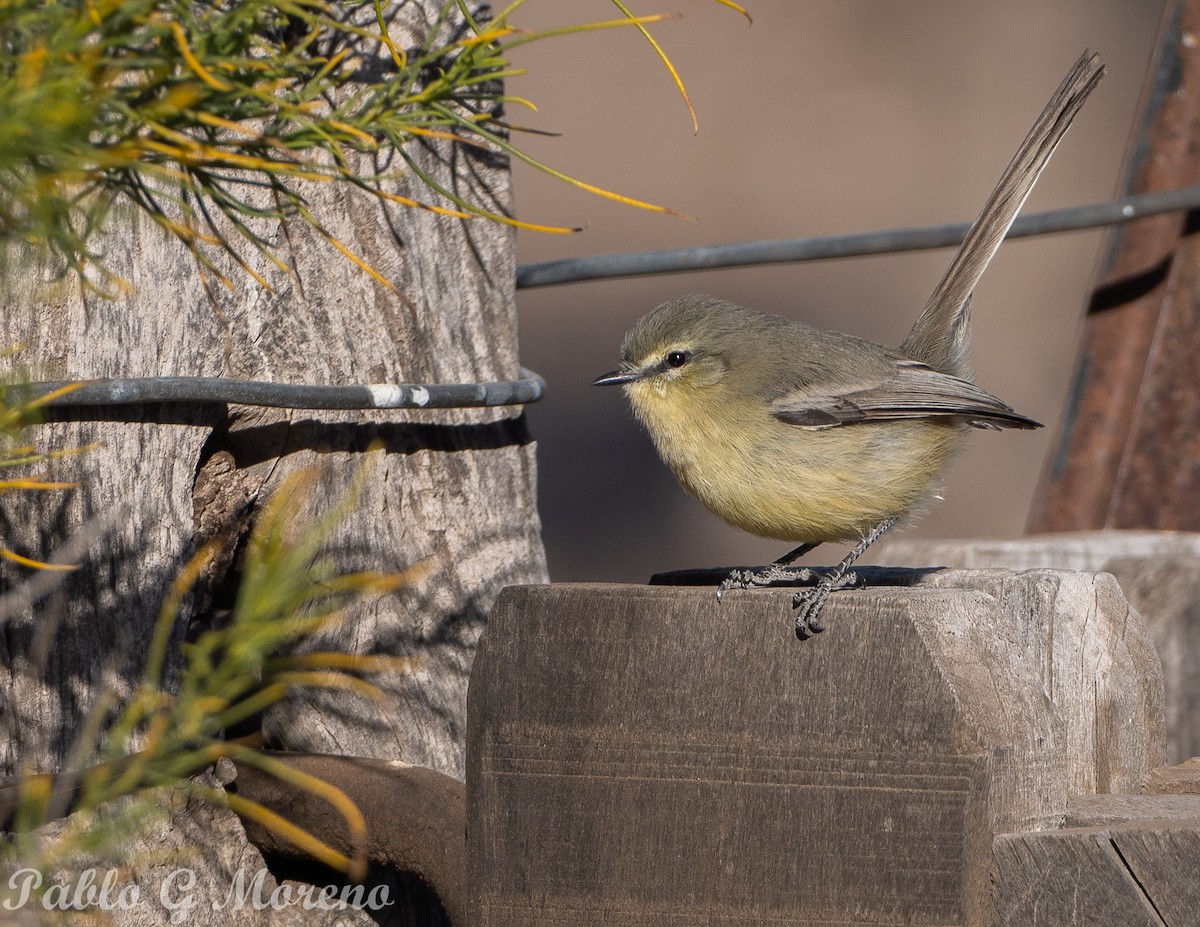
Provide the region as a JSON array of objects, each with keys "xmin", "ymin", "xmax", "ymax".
[{"xmin": 0, "ymin": 0, "xmax": 546, "ymax": 916}]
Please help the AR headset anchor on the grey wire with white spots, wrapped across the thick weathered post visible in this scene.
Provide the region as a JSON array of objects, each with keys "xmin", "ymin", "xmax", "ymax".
[{"xmin": 25, "ymin": 367, "xmax": 546, "ymax": 409}]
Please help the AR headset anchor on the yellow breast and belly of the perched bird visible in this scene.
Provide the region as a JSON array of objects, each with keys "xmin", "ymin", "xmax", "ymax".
[{"xmin": 628, "ymin": 383, "xmax": 958, "ymax": 543}]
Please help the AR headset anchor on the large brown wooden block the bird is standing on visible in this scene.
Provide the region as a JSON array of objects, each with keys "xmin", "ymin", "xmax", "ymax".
[{"xmin": 467, "ymin": 578, "xmax": 1160, "ymax": 927}]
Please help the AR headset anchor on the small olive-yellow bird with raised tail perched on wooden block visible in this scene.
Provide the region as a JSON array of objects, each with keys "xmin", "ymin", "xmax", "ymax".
[{"xmin": 594, "ymin": 52, "xmax": 1104, "ymax": 638}]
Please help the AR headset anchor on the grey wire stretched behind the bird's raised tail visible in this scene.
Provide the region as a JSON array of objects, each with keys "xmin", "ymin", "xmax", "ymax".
[{"xmin": 517, "ymin": 178, "xmax": 1200, "ymax": 288}]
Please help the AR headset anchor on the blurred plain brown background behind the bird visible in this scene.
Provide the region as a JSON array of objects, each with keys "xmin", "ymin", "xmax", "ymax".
[{"xmin": 508, "ymin": 0, "xmax": 1162, "ymax": 582}]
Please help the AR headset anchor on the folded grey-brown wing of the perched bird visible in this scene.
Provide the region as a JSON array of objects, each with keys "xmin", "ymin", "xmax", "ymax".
[{"xmin": 772, "ymin": 359, "xmax": 1040, "ymax": 429}]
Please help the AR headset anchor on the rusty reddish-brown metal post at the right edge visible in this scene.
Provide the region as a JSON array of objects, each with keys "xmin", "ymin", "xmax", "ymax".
[{"xmin": 1028, "ymin": 0, "xmax": 1200, "ymax": 532}]
